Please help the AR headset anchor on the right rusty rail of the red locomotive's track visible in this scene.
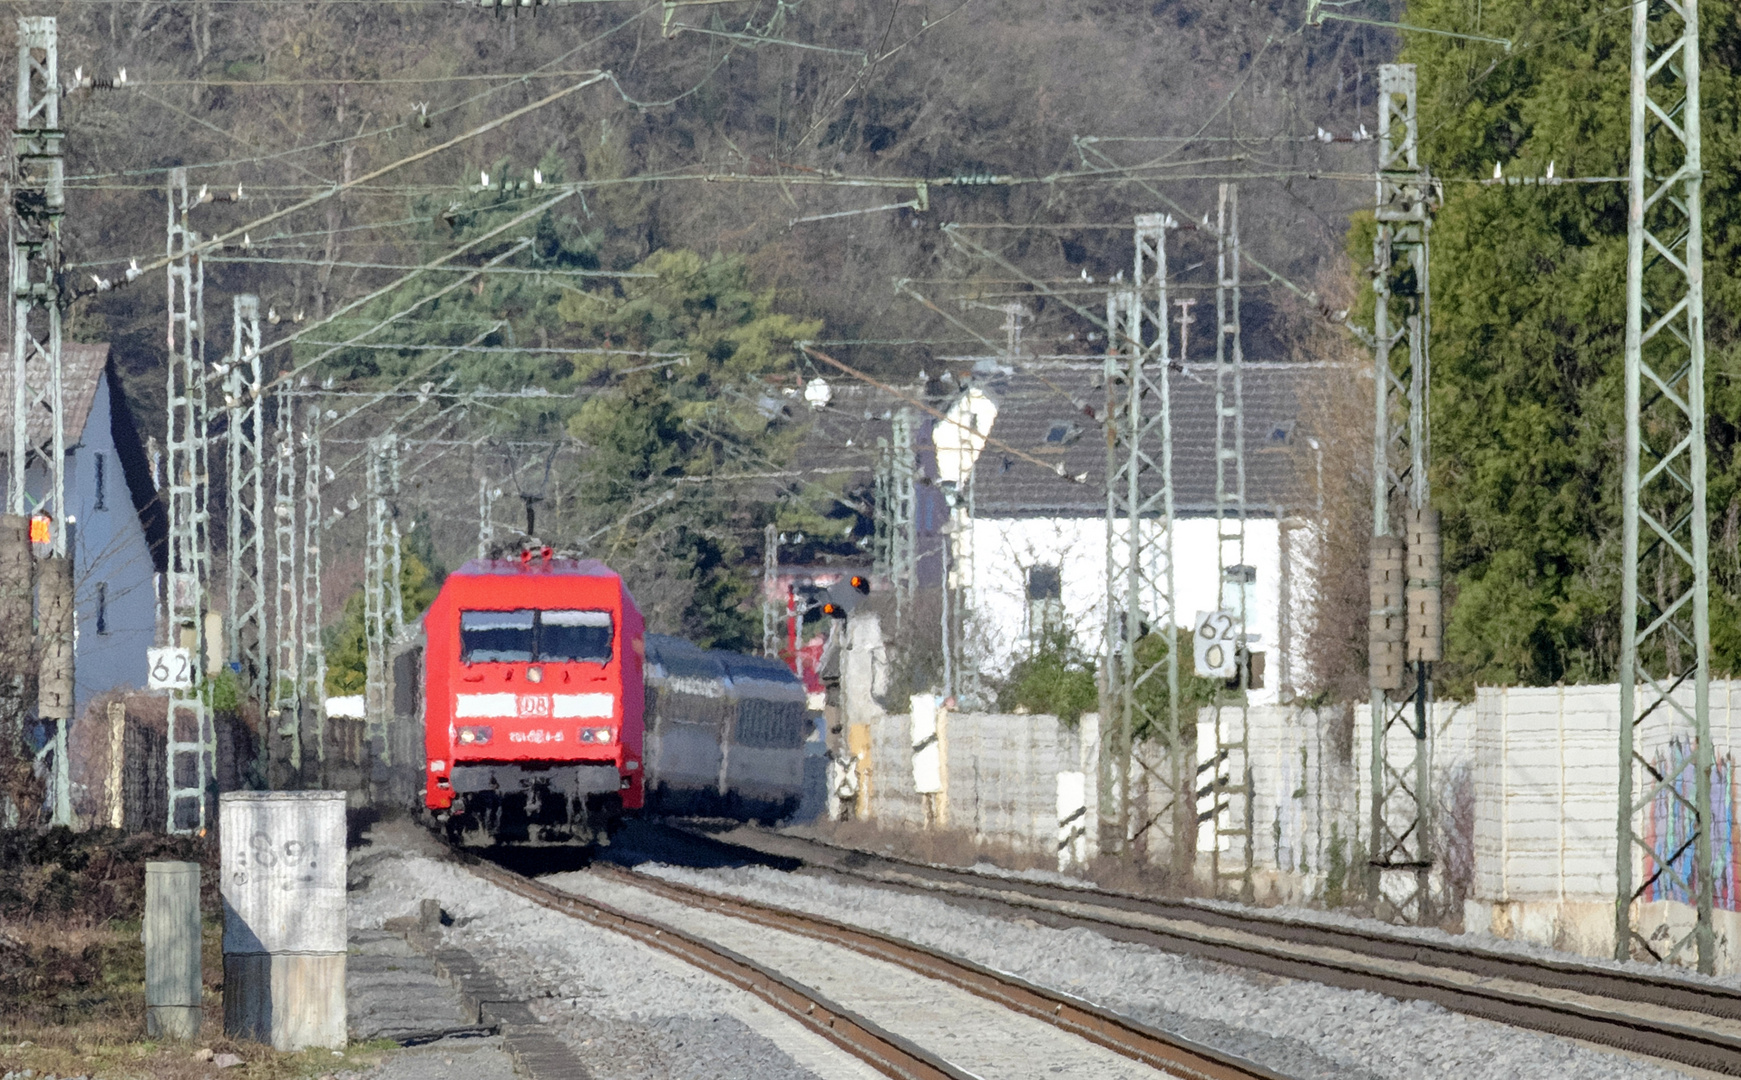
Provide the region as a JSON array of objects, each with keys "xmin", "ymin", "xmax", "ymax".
[{"xmin": 592, "ymin": 864, "xmax": 1287, "ymax": 1080}]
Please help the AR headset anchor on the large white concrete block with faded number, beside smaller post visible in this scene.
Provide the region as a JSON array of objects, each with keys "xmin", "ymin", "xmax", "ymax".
[{"xmin": 218, "ymin": 791, "xmax": 346, "ymax": 1050}]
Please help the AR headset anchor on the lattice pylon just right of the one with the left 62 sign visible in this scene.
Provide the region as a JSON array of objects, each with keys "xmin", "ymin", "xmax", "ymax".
[{"xmin": 223, "ymin": 294, "xmax": 272, "ymax": 738}]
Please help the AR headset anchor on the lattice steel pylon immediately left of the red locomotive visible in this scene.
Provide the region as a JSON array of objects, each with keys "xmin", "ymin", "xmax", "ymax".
[{"xmin": 362, "ymin": 432, "xmax": 406, "ymax": 765}]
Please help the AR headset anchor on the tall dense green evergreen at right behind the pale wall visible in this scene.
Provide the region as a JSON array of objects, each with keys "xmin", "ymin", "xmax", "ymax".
[{"xmin": 1392, "ymin": 0, "xmax": 1741, "ymax": 692}]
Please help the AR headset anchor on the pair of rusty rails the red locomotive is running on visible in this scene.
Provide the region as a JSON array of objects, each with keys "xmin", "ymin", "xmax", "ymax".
[{"xmin": 467, "ymin": 861, "xmax": 1287, "ymax": 1080}]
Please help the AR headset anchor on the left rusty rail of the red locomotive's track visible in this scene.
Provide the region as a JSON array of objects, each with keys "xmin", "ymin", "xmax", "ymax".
[{"xmin": 463, "ymin": 859, "xmax": 978, "ymax": 1080}]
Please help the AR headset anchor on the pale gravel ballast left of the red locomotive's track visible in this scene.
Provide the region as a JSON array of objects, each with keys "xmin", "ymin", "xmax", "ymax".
[{"xmin": 350, "ymin": 838, "xmax": 877, "ymax": 1080}]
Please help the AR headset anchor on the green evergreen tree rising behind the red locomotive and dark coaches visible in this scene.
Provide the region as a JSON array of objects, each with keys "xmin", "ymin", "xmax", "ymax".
[{"xmin": 557, "ymin": 251, "xmax": 820, "ymax": 648}]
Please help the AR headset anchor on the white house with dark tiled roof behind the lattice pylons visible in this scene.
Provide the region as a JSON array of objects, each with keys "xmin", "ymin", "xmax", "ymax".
[{"xmin": 931, "ymin": 359, "xmax": 1321, "ymax": 704}]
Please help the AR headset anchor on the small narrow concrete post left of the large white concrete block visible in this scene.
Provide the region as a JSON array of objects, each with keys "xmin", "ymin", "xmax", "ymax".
[{"xmin": 145, "ymin": 862, "xmax": 200, "ymax": 1038}]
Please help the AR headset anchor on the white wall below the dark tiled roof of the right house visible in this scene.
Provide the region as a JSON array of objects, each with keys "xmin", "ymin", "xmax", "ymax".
[{"xmin": 956, "ymin": 517, "xmax": 1302, "ymax": 705}]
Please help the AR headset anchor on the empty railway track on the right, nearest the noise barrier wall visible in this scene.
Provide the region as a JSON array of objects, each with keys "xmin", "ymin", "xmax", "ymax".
[{"xmin": 686, "ymin": 829, "xmax": 1741, "ymax": 1077}]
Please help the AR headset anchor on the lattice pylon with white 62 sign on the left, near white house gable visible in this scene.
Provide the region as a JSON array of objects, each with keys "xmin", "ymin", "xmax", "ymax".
[{"xmin": 164, "ymin": 169, "xmax": 214, "ymax": 833}]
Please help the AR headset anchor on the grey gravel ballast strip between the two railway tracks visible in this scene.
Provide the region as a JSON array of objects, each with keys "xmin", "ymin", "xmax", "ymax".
[{"xmin": 637, "ymin": 864, "xmax": 1685, "ymax": 1080}]
